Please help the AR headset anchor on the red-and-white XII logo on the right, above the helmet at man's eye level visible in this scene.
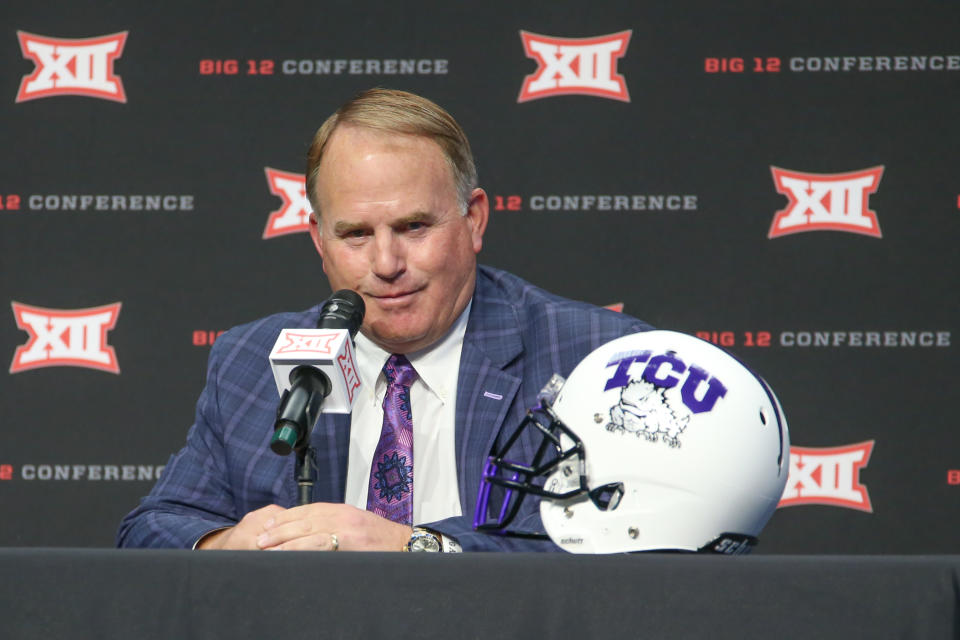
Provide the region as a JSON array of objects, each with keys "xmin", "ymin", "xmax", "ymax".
[{"xmin": 767, "ymin": 166, "xmax": 883, "ymax": 238}]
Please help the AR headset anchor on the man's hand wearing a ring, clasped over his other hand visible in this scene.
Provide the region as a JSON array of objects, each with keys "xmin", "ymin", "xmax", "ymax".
[{"xmin": 253, "ymin": 502, "xmax": 413, "ymax": 551}]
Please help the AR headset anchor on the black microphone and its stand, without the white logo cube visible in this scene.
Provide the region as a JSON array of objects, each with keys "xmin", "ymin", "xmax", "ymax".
[{"xmin": 270, "ymin": 289, "xmax": 365, "ymax": 505}]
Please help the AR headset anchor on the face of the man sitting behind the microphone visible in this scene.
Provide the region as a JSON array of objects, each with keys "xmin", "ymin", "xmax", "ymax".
[{"xmin": 310, "ymin": 125, "xmax": 489, "ymax": 353}]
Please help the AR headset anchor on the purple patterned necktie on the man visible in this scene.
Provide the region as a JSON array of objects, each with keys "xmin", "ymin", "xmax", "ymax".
[{"xmin": 367, "ymin": 354, "xmax": 417, "ymax": 524}]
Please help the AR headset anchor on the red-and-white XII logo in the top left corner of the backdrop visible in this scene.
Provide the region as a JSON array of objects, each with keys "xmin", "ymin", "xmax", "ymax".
[{"xmin": 16, "ymin": 31, "xmax": 127, "ymax": 102}]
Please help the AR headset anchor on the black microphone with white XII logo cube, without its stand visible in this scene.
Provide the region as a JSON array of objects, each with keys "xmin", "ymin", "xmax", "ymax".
[{"xmin": 270, "ymin": 289, "xmax": 365, "ymax": 456}]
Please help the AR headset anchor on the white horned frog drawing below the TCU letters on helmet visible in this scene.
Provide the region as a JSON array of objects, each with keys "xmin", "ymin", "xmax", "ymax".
[{"xmin": 606, "ymin": 379, "xmax": 690, "ymax": 448}]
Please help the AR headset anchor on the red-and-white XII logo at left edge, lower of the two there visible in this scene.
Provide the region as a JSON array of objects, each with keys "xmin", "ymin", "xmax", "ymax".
[{"xmin": 10, "ymin": 302, "xmax": 120, "ymax": 373}]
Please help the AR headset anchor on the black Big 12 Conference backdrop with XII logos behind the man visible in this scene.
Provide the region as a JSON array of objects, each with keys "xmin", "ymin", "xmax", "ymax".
[{"xmin": 0, "ymin": 0, "xmax": 960, "ymax": 553}]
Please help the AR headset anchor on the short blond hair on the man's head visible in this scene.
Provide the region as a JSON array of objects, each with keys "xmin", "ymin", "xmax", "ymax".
[{"xmin": 306, "ymin": 88, "xmax": 477, "ymax": 215}]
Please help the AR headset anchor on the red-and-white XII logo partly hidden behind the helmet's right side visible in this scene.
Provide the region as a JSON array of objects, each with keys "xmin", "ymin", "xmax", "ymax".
[{"xmin": 778, "ymin": 440, "xmax": 874, "ymax": 513}]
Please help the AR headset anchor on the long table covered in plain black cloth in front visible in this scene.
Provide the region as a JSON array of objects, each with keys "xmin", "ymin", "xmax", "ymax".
[{"xmin": 0, "ymin": 548, "xmax": 960, "ymax": 640}]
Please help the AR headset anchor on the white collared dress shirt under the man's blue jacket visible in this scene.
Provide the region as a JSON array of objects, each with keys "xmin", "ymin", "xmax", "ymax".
[{"xmin": 344, "ymin": 302, "xmax": 473, "ymax": 525}]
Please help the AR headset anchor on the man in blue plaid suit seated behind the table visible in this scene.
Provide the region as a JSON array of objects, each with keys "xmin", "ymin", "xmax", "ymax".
[{"xmin": 118, "ymin": 89, "xmax": 649, "ymax": 551}]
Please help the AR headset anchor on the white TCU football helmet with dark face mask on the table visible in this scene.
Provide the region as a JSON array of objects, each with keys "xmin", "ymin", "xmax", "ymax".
[{"xmin": 474, "ymin": 331, "xmax": 790, "ymax": 554}]
